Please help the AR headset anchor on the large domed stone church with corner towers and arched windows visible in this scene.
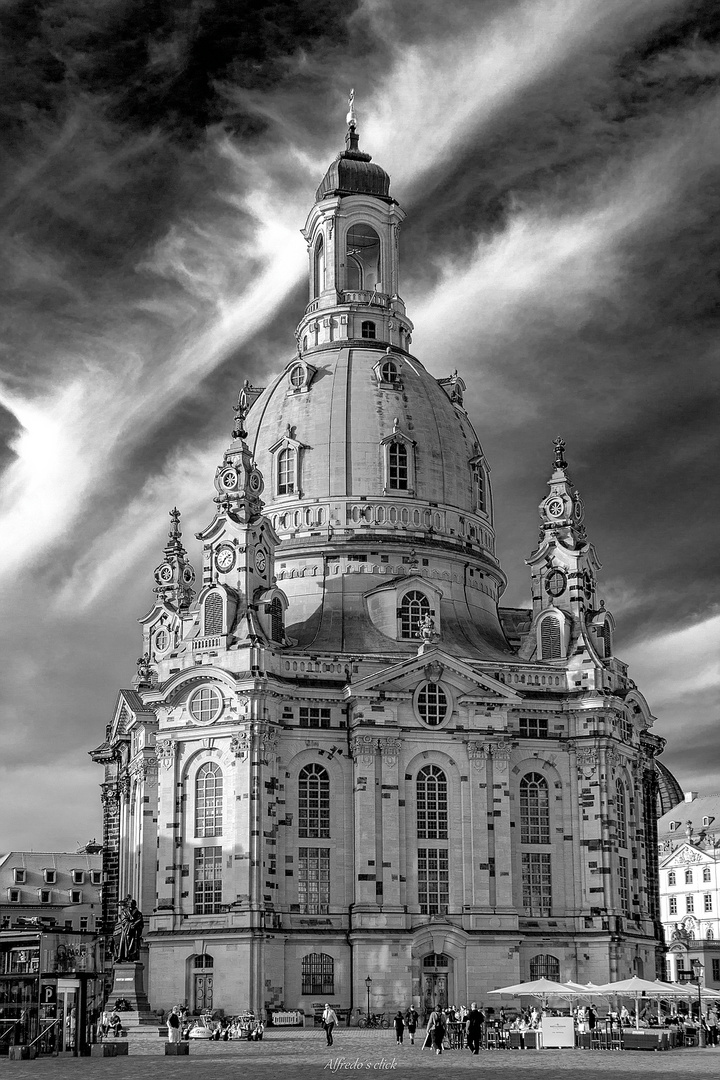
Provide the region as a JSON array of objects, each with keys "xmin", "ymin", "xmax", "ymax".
[{"xmin": 92, "ymin": 105, "xmax": 664, "ymax": 1018}]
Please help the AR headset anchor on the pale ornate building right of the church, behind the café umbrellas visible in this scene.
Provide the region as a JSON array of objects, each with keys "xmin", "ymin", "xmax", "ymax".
[{"xmin": 657, "ymin": 792, "xmax": 720, "ymax": 989}]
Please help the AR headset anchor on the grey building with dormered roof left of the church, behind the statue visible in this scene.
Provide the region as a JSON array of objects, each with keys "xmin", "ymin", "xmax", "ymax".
[{"xmin": 0, "ymin": 845, "xmax": 103, "ymax": 931}]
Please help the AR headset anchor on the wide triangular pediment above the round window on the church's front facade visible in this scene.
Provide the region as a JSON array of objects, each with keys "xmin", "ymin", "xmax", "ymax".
[{"xmin": 345, "ymin": 648, "xmax": 522, "ymax": 705}]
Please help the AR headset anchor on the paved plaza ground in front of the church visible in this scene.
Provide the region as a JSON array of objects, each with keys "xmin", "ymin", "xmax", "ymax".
[{"xmin": 0, "ymin": 1028, "xmax": 720, "ymax": 1080}]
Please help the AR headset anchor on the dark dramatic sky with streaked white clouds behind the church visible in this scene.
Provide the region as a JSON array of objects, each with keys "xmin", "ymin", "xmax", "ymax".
[{"xmin": 0, "ymin": 0, "xmax": 720, "ymax": 851}]
